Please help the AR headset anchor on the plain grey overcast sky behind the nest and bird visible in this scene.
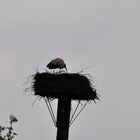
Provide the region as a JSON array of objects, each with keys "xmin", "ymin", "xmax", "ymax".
[{"xmin": 0, "ymin": 0, "xmax": 140, "ymax": 140}]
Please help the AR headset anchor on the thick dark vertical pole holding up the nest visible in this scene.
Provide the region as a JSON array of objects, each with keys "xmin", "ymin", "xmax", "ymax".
[{"xmin": 56, "ymin": 98, "xmax": 71, "ymax": 140}]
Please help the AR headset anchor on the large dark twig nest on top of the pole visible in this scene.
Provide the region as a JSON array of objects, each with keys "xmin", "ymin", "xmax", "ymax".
[{"xmin": 31, "ymin": 72, "xmax": 99, "ymax": 101}]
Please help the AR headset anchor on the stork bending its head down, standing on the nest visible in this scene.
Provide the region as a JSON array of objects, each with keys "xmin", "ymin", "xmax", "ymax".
[{"xmin": 47, "ymin": 58, "xmax": 67, "ymax": 72}]
